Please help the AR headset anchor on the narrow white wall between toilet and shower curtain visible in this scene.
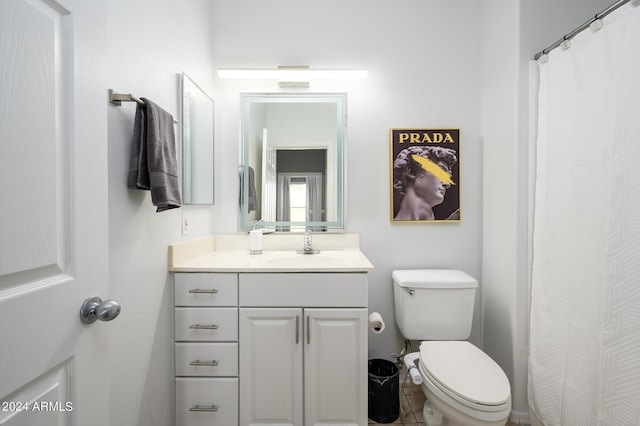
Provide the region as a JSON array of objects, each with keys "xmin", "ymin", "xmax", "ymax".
[{"xmin": 481, "ymin": 0, "xmax": 612, "ymax": 421}]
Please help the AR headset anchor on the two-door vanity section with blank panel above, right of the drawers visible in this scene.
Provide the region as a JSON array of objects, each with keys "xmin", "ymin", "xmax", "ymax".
[{"xmin": 239, "ymin": 273, "xmax": 368, "ymax": 426}]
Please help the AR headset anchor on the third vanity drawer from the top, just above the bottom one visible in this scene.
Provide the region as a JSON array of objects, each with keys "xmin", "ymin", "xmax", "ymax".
[{"xmin": 176, "ymin": 343, "xmax": 238, "ymax": 376}]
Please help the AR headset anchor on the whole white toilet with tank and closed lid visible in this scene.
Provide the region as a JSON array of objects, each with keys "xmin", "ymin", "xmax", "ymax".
[{"xmin": 392, "ymin": 269, "xmax": 511, "ymax": 426}]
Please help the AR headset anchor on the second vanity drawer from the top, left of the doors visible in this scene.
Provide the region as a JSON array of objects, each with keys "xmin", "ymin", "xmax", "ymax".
[{"xmin": 175, "ymin": 308, "xmax": 238, "ymax": 342}]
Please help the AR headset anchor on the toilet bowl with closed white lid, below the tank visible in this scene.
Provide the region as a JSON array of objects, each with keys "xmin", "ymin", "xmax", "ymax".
[{"xmin": 418, "ymin": 341, "xmax": 511, "ymax": 426}]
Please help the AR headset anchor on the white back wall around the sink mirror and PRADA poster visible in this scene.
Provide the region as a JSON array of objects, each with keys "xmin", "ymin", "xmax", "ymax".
[{"xmin": 212, "ymin": 0, "xmax": 482, "ymax": 358}]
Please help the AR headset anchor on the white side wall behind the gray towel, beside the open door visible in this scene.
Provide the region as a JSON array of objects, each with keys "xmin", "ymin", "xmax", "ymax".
[{"xmin": 106, "ymin": 0, "xmax": 212, "ymax": 426}]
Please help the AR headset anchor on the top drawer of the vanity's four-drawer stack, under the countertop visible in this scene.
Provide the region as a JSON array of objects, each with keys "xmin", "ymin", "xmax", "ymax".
[{"xmin": 175, "ymin": 273, "xmax": 238, "ymax": 306}]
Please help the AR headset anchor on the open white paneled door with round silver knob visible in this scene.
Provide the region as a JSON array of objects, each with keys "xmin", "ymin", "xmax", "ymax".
[{"xmin": 0, "ymin": 0, "xmax": 109, "ymax": 426}]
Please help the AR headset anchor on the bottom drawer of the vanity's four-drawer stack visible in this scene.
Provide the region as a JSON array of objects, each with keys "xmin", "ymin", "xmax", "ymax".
[{"xmin": 176, "ymin": 377, "xmax": 238, "ymax": 426}]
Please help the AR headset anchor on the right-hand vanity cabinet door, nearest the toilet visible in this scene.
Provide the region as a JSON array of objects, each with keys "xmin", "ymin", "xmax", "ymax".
[{"xmin": 304, "ymin": 309, "xmax": 367, "ymax": 426}]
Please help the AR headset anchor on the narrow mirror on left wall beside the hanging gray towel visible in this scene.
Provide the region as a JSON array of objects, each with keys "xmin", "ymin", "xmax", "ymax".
[{"xmin": 180, "ymin": 73, "xmax": 214, "ymax": 204}]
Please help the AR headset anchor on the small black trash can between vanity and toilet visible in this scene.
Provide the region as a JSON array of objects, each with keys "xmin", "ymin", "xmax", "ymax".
[{"xmin": 369, "ymin": 359, "xmax": 400, "ymax": 423}]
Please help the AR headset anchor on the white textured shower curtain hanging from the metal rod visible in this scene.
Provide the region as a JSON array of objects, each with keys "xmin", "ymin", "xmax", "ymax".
[{"xmin": 529, "ymin": 3, "xmax": 640, "ymax": 426}]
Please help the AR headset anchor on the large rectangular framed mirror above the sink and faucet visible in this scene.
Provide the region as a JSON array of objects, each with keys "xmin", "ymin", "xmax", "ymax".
[{"xmin": 240, "ymin": 93, "xmax": 346, "ymax": 232}]
